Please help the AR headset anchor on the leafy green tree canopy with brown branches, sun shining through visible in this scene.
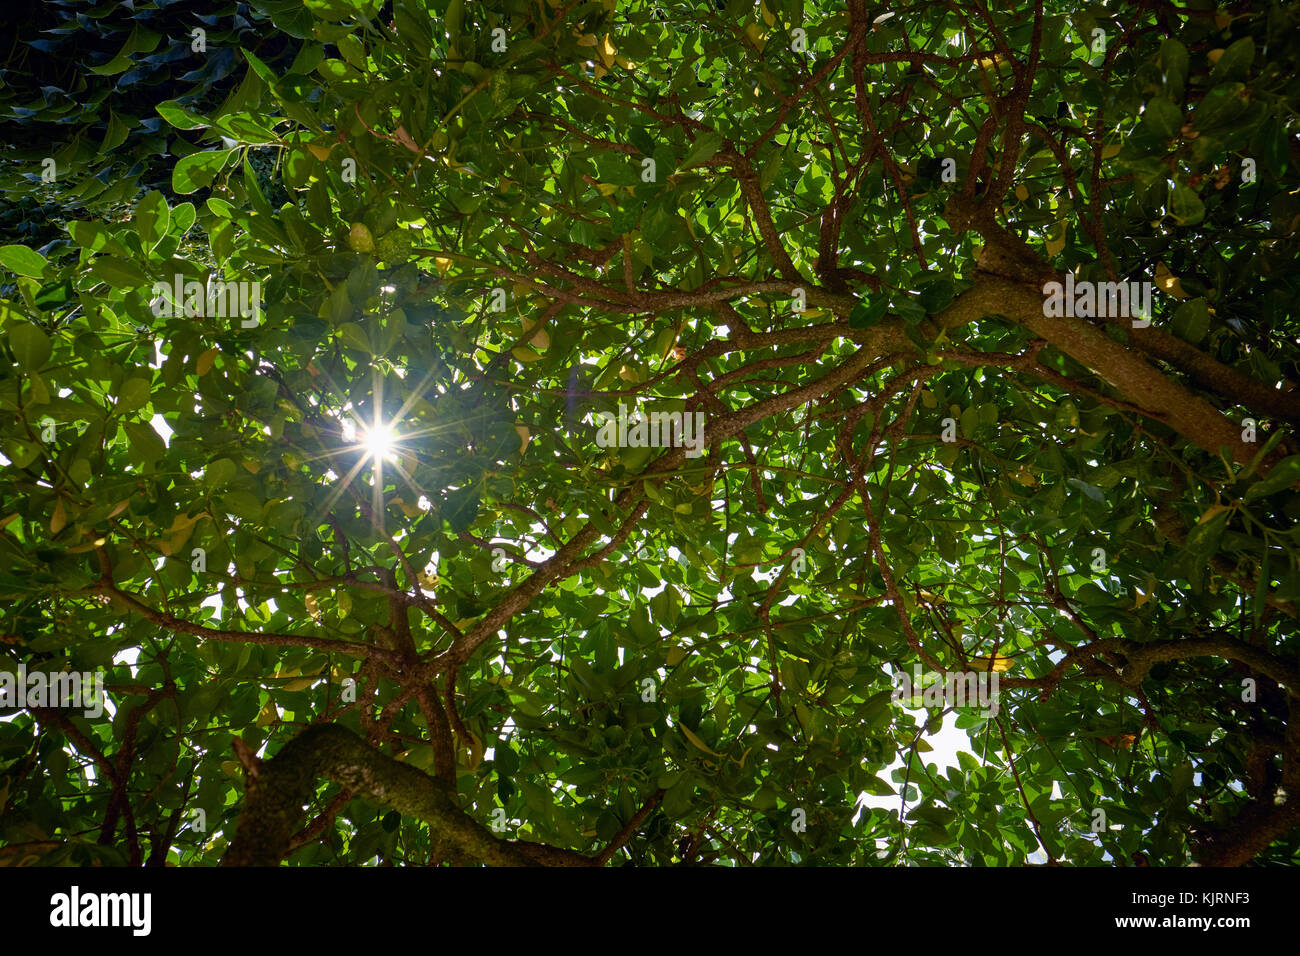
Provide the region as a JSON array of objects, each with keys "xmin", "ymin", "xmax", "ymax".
[{"xmin": 0, "ymin": 0, "xmax": 1300, "ymax": 865}]
